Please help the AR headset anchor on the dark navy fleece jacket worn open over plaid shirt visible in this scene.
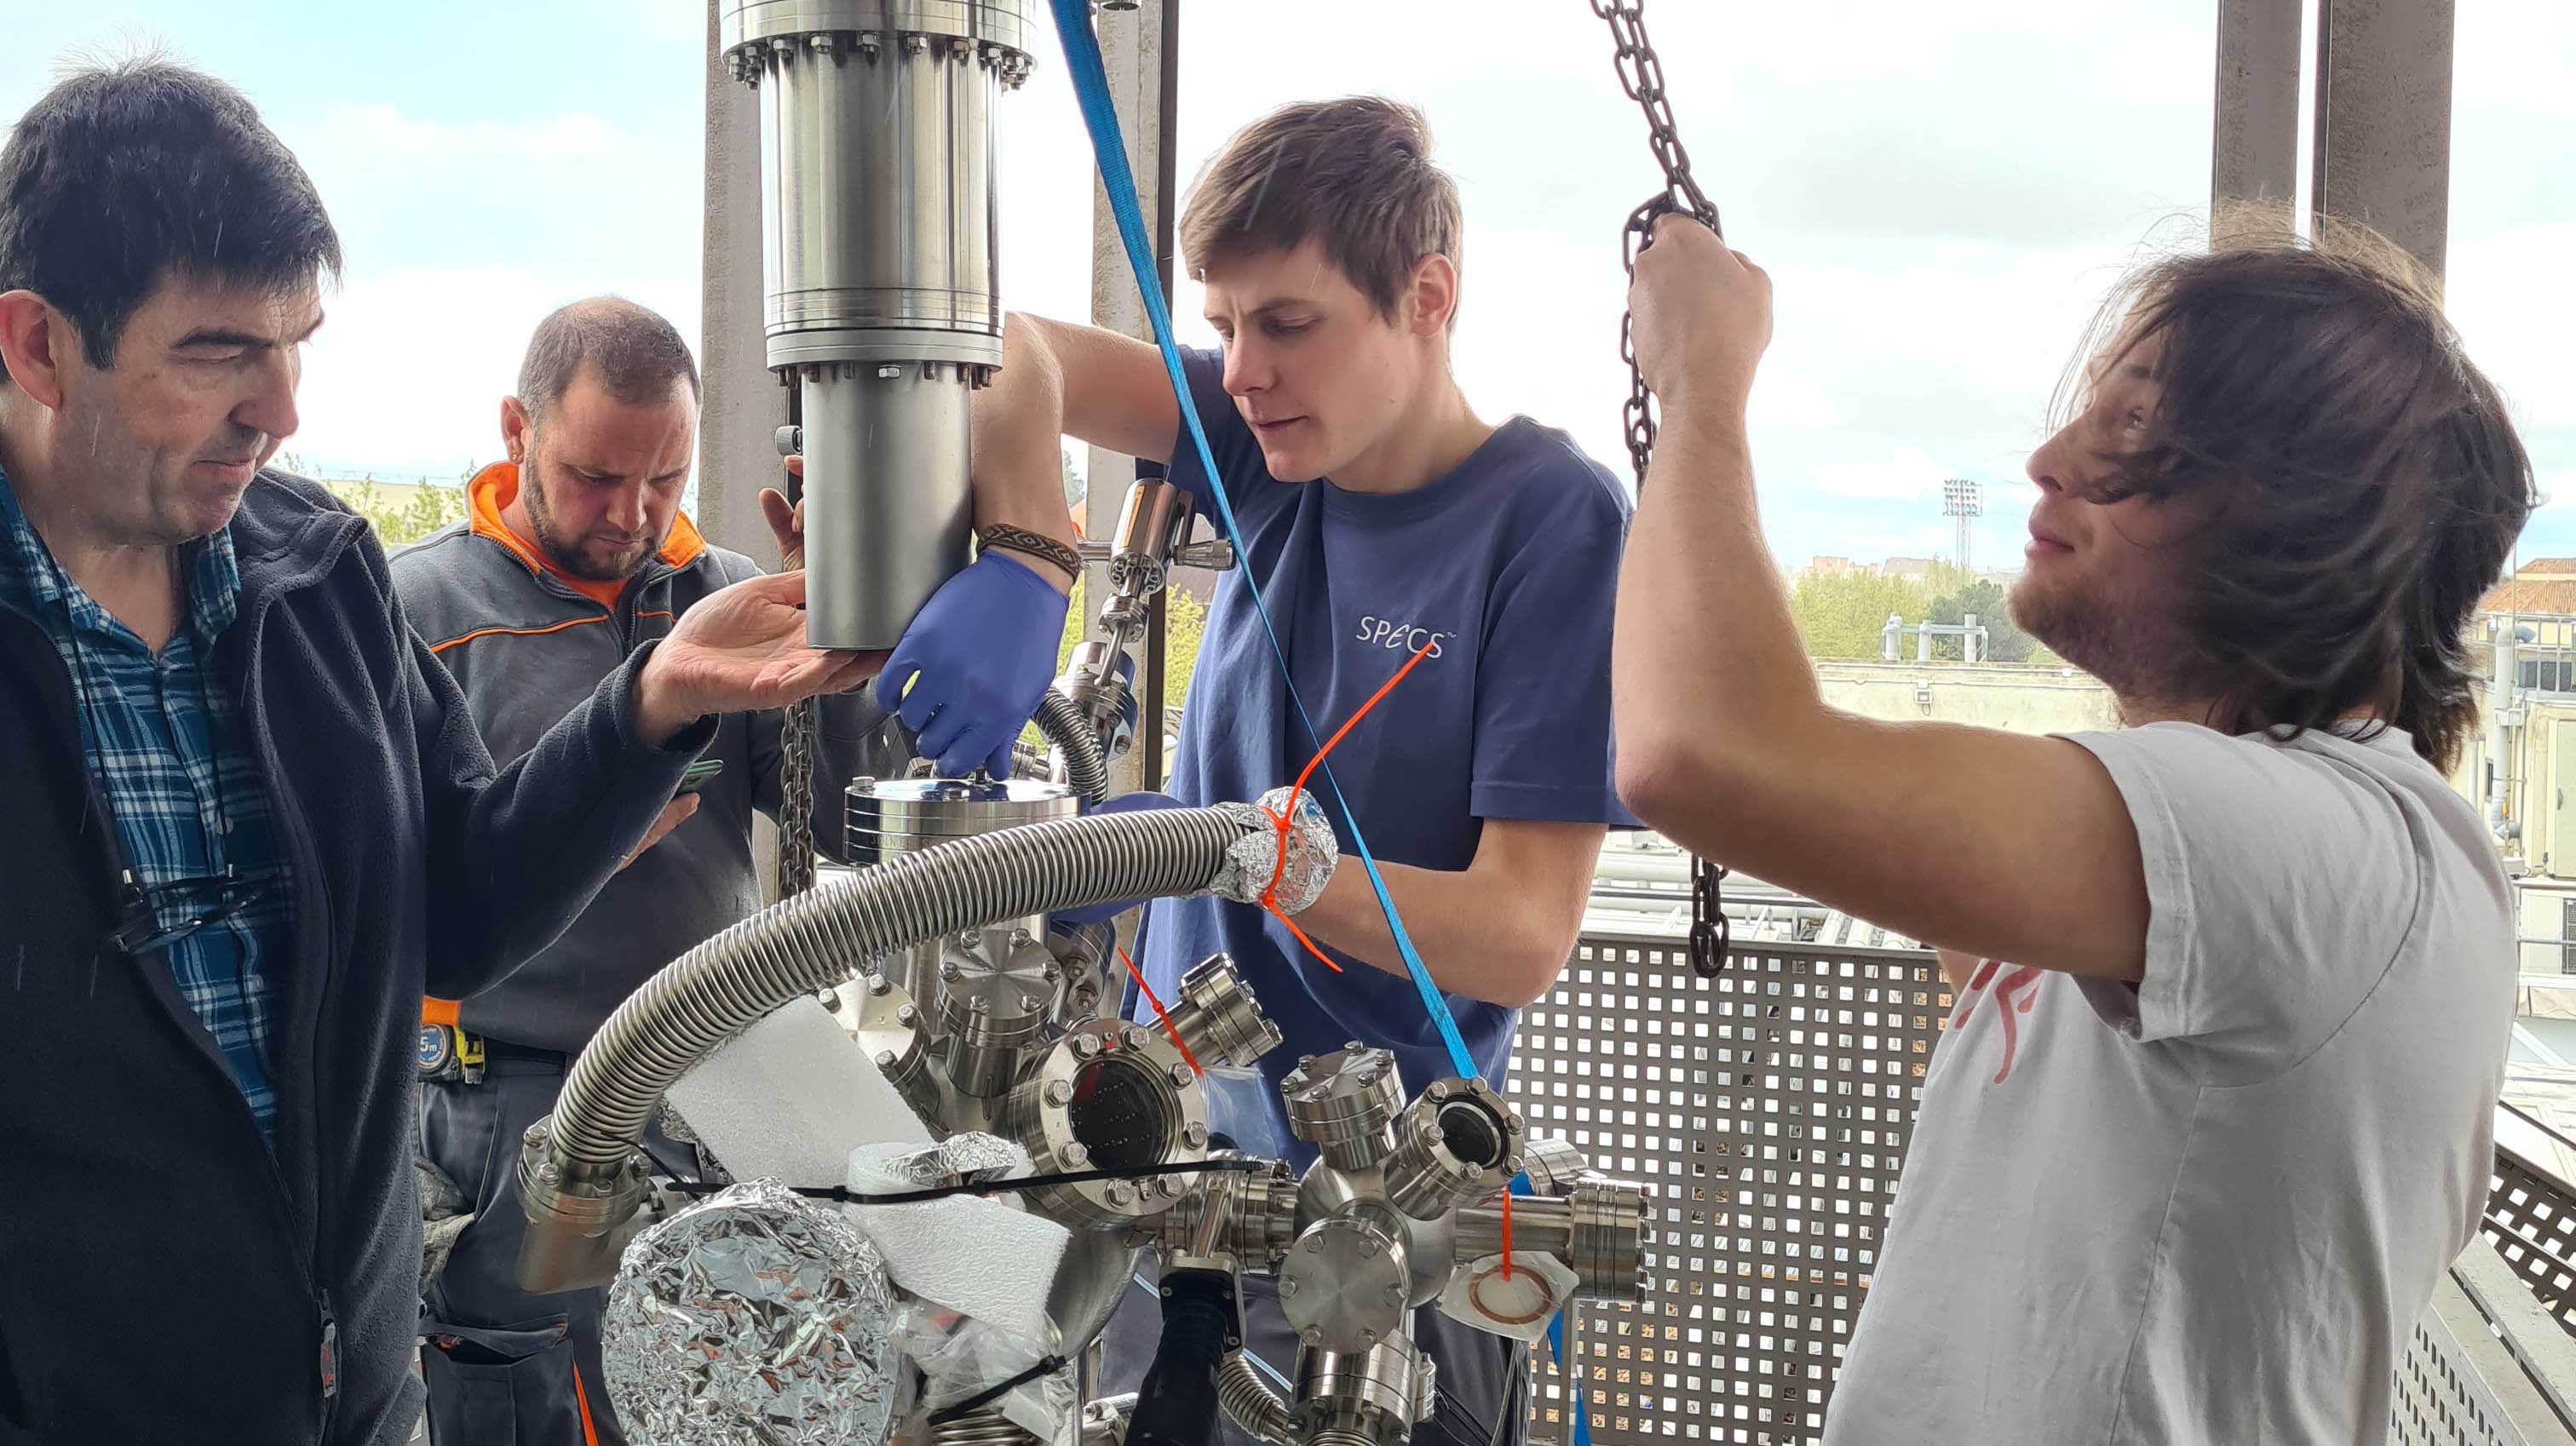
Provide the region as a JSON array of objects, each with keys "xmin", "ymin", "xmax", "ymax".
[{"xmin": 0, "ymin": 471, "xmax": 714, "ymax": 1446}]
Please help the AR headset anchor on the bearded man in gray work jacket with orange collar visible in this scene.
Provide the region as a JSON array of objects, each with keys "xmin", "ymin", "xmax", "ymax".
[{"xmin": 394, "ymin": 296, "xmax": 909, "ymax": 1443}]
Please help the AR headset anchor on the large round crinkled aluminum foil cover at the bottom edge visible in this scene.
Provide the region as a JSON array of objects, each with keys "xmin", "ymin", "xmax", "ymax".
[{"xmin": 601, "ymin": 1181, "xmax": 904, "ymax": 1446}]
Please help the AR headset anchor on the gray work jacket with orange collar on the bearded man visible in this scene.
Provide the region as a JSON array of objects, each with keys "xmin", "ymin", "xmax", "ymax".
[{"xmin": 392, "ymin": 463, "xmax": 911, "ymax": 1055}]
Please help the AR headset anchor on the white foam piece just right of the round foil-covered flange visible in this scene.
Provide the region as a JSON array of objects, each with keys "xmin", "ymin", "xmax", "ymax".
[{"xmin": 845, "ymin": 1145, "xmax": 1074, "ymax": 1343}]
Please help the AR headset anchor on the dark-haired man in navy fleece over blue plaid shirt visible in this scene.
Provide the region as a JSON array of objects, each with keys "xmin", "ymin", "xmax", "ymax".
[{"xmin": 0, "ymin": 62, "xmax": 873, "ymax": 1443}]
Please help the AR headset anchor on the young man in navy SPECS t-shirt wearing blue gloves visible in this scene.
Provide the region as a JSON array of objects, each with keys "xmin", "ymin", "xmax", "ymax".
[{"xmin": 974, "ymin": 100, "xmax": 1633, "ymax": 1446}]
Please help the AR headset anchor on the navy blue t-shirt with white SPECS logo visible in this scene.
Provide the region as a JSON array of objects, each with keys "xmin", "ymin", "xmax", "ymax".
[{"xmin": 1141, "ymin": 341, "xmax": 1636, "ymax": 1161}]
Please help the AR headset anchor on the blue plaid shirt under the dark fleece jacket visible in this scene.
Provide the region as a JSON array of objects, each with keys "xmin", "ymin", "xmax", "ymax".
[{"xmin": 0, "ymin": 460, "xmax": 291, "ymax": 1150}]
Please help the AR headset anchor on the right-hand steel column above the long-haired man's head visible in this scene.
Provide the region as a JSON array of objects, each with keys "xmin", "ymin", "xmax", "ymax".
[{"xmin": 2311, "ymin": 0, "xmax": 2455, "ymax": 278}]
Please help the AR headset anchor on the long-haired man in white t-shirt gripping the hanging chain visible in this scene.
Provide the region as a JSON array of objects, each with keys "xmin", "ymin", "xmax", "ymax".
[{"xmin": 1613, "ymin": 221, "xmax": 2533, "ymax": 1446}]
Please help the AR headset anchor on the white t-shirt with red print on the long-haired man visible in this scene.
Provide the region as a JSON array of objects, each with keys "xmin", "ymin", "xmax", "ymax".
[{"xmin": 1826, "ymin": 723, "xmax": 2514, "ymax": 1446}]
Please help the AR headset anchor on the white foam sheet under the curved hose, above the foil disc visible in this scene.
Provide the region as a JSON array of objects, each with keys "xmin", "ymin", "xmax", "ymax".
[{"xmin": 670, "ymin": 996, "xmax": 930, "ymax": 1186}]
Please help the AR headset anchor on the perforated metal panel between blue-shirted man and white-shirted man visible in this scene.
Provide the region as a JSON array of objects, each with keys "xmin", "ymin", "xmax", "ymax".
[{"xmin": 1507, "ymin": 934, "xmax": 1950, "ymax": 1446}]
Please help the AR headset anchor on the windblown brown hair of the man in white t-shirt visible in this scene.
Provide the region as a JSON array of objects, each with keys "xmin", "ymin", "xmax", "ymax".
[{"xmin": 2058, "ymin": 221, "xmax": 2538, "ymax": 772}]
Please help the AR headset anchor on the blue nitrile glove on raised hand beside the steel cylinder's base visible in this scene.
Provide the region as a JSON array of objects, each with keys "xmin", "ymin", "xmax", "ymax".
[{"xmin": 876, "ymin": 551, "xmax": 1064, "ymax": 777}]
